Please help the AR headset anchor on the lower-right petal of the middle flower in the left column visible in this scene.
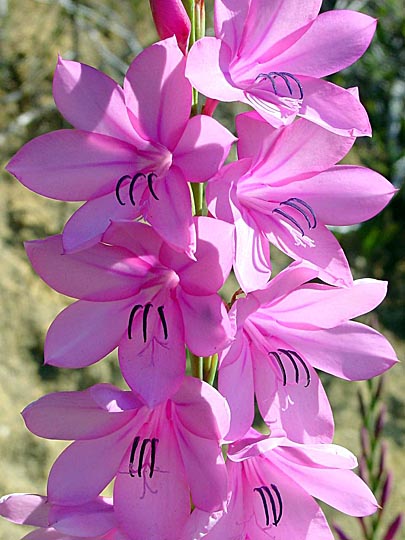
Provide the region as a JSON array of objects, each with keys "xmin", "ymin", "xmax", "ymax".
[{"xmin": 178, "ymin": 287, "xmax": 233, "ymax": 356}]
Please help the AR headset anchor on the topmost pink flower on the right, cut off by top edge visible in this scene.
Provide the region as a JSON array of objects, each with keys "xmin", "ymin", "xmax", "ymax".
[{"xmin": 186, "ymin": 0, "xmax": 376, "ymax": 136}]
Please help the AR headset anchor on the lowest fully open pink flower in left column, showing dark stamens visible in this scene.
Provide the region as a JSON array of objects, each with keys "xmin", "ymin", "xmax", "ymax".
[{"xmin": 23, "ymin": 377, "xmax": 229, "ymax": 540}]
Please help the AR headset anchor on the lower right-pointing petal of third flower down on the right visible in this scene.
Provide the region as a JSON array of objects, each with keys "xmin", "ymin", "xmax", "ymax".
[{"xmin": 280, "ymin": 321, "xmax": 398, "ymax": 381}]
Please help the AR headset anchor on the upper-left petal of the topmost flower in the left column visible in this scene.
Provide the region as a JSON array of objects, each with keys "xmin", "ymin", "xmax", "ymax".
[{"xmin": 53, "ymin": 57, "xmax": 145, "ymax": 148}]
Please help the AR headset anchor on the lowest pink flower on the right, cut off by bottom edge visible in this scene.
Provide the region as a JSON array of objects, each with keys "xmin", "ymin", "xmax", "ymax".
[{"xmin": 182, "ymin": 430, "xmax": 378, "ymax": 540}]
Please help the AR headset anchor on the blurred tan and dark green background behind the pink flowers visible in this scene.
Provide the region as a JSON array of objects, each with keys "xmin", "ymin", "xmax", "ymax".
[{"xmin": 0, "ymin": 0, "xmax": 405, "ymax": 540}]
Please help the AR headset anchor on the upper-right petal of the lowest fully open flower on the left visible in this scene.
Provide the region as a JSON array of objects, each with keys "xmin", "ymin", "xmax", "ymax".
[{"xmin": 171, "ymin": 377, "xmax": 230, "ymax": 441}]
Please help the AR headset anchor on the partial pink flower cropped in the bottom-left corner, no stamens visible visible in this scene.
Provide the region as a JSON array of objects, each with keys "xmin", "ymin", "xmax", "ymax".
[{"xmin": 0, "ymin": 493, "xmax": 126, "ymax": 540}]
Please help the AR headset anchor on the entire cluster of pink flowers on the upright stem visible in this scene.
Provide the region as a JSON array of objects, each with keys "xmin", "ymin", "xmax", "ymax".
[{"xmin": 0, "ymin": 0, "xmax": 397, "ymax": 540}]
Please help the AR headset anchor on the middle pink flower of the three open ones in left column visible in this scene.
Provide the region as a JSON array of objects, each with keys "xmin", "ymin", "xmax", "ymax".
[{"xmin": 26, "ymin": 217, "xmax": 233, "ymax": 406}]
